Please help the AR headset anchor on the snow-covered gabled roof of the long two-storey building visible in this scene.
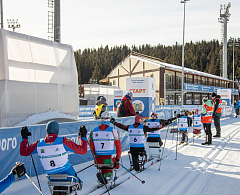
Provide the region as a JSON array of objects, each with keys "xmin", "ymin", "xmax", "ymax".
[{"xmin": 107, "ymin": 52, "xmax": 229, "ymax": 81}]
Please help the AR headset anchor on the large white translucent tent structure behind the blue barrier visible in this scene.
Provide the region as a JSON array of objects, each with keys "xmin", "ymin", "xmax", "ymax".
[{"xmin": 0, "ymin": 29, "xmax": 79, "ymax": 127}]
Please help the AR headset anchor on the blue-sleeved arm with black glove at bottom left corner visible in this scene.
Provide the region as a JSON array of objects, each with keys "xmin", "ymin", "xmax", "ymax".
[{"xmin": 0, "ymin": 163, "xmax": 26, "ymax": 194}]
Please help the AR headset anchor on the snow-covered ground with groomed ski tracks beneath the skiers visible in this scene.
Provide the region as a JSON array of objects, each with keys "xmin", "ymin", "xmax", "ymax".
[{"xmin": 2, "ymin": 117, "xmax": 240, "ymax": 195}]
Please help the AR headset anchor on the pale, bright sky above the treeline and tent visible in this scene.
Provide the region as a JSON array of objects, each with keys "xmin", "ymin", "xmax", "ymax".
[{"xmin": 3, "ymin": 0, "xmax": 240, "ymax": 50}]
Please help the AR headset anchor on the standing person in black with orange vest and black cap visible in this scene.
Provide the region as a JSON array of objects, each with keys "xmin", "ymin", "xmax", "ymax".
[{"xmin": 212, "ymin": 92, "xmax": 222, "ymax": 137}]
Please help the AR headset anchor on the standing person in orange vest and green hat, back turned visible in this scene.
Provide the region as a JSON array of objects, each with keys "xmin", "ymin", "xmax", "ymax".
[{"xmin": 201, "ymin": 96, "xmax": 213, "ymax": 145}]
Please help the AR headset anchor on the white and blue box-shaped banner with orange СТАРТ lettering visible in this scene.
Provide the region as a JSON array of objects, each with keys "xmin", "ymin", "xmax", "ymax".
[{"xmin": 126, "ymin": 77, "xmax": 156, "ymax": 117}]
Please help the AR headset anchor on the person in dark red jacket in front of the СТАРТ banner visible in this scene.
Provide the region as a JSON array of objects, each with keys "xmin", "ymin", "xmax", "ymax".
[{"xmin": 117, "ymin": 91, "xmax": 136, "ymax": 117}]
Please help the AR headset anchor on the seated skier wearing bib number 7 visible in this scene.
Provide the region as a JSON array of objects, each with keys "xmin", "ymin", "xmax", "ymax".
[{"xmin": 89, "ymin": 112, "xmax": 122, "ymax": 184}]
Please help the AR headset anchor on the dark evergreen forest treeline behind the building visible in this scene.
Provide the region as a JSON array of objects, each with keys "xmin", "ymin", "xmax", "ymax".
[{"xmin": 74, "ymin": 40, "xmax": 240, "ymax": 84}]
